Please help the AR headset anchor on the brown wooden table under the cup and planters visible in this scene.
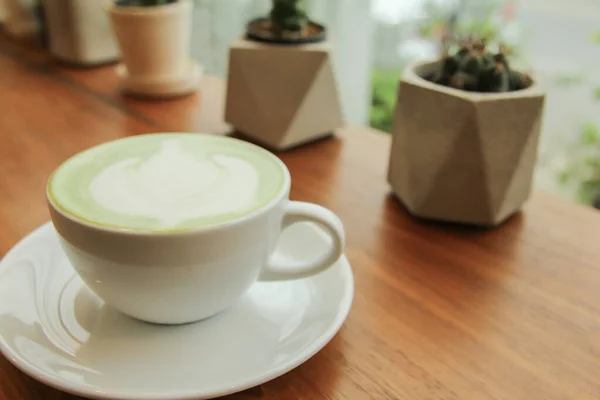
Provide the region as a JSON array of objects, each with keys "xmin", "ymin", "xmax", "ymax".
[{"xmin": 0, "ymin": 36, "xmax": 600, "ymax": 400}]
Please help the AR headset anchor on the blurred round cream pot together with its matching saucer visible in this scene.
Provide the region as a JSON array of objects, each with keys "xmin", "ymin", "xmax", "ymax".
[{"xmin": 108, "ymin": 0, "xmax": 202, "ymax": 97}]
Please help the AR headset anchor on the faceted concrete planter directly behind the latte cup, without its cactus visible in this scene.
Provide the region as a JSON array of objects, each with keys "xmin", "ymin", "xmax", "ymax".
[{"xmin": 225, "ymin": 39, "xmax": 342, "ymax": 150}]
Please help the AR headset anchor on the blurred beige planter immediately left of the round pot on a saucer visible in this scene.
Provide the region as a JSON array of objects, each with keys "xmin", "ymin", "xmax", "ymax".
[{"xmin": 44, "ymin": 0, "xmax": 119, "ymax": 66}]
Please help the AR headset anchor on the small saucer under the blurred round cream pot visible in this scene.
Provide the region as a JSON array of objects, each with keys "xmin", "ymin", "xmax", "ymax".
[{"xmin": 115, "ymin": 61, "xmax": 203, "ymax": 97}]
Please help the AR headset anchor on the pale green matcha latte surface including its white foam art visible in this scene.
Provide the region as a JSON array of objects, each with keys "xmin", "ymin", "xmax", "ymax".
[{"xmin": 48, "ymin": 134, "xmax": 286, "ymax": 231}]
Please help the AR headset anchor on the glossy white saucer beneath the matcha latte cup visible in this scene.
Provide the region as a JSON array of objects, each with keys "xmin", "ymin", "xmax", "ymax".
[{"xmin": 0, "ymin": 223, "xmax": 354, "ymax": 400}]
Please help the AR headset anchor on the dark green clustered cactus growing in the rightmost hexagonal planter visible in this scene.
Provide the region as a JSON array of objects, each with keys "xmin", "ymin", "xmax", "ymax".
[{"xmin": 432, "ymin": 39, "xmax": 532, "ymax": 93}]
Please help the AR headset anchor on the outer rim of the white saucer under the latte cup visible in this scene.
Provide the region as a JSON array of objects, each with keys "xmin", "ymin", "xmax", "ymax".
[{"xmin": 0, "ymin": 221, "xmax": 355, "ymax": 400}]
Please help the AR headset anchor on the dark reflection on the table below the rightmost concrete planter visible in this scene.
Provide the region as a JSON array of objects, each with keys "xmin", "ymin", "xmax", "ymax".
[{"xmin": 366, "ymin": 194, "xmax": 524, "ymax": 347}]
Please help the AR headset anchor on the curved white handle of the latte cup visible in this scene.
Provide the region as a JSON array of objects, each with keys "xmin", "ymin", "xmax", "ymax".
[{"xmin": 259, "ymin": 201, "xmax": 345, "ymax": 281}]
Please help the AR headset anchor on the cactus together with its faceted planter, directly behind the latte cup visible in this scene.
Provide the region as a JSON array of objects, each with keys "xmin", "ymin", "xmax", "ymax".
[{"xmin": 225, "ymin": 0, "xmax": 342, "ymax": 150}]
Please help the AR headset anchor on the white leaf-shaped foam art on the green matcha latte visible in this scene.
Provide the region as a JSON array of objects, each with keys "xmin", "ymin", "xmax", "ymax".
[{"xmin": 89, "ymin": 139, "xmax": 259, "ymax": 228}]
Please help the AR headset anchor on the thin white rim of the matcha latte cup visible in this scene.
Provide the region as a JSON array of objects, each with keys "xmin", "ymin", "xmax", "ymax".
[{"xmin": 46, "ymin": 132, "xmax": 291, "ymax": 238}]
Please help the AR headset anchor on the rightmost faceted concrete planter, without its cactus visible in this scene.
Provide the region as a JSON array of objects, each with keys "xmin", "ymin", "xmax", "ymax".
[{"xmin": 388, "ymin": 62, "xmax": 545, "ymax": 227}]
